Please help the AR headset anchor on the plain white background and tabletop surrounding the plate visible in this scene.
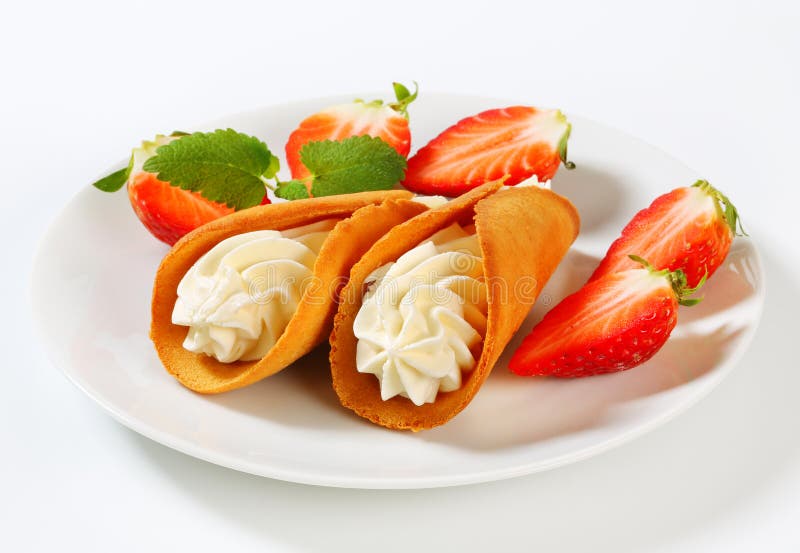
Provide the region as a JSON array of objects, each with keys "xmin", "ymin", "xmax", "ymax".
[{"xmin": 0, "ymin": 0, "xmax": 800, "ymax": 552}]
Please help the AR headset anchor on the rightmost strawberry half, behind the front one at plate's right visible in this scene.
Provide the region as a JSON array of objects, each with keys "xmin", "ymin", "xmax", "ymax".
[{"xmin": 589, "ymin": 180, "xmax": 744, "ymax": 286}]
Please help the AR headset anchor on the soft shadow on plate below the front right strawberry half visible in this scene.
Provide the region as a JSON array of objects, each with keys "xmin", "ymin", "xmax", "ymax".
[{"xmin": 420, "ymin": 327, "xmax": 742, "ymax": 451}]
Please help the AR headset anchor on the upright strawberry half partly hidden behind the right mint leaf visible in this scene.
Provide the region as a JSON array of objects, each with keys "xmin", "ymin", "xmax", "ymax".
[{"xmin": 286, "ymin": 83, "xmax": 417, "ymax": 179}]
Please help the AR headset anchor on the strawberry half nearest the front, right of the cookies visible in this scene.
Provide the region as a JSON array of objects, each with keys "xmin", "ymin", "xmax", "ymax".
[{"xmin": 509, "ymin": 257, "xmax": 702, "ymax": 378}]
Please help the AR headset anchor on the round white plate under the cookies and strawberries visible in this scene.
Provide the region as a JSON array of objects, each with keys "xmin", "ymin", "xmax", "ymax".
[{"xmin": 32, "ymin": 94, "xmax": 764, "ymax": 488}]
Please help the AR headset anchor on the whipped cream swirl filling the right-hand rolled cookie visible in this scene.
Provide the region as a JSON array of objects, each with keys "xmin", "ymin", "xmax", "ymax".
[{"xmin": 353, "ymin": 224, "xmax": 487, "ymax": 405}]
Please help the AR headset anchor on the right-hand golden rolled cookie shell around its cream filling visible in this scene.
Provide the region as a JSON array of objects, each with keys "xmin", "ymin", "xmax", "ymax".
[{"xmin": 330, "ymin": 183, "xmax": 579, "ymax": 431}]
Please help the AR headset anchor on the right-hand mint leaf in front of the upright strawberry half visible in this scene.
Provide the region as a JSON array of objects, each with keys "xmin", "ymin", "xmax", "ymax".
[{"xmin": 300, "ymin": 135, "xmax": 406, "ymax": 196}]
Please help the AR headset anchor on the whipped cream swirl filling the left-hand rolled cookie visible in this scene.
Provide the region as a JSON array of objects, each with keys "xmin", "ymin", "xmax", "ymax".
[{"xmin": 172, "ymin": 219, "xmax": 338, "ymax": 363}]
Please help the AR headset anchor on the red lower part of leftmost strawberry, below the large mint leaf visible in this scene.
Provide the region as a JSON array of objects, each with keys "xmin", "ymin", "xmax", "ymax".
[{"xmin": 128, "ymin": 172, "xmax": 236, "ymax": 246}]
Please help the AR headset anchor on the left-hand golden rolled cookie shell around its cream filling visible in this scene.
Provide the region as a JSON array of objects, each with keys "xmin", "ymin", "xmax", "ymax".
[{"xmin": 150, "ymin": 190, "xmax": 427, "ymax": 393}]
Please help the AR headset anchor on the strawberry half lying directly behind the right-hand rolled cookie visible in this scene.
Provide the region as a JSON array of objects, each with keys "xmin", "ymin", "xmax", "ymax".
[{"xmin": 403, "ymin": 106, "xmax": 575, "ymax": 196}]
